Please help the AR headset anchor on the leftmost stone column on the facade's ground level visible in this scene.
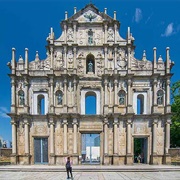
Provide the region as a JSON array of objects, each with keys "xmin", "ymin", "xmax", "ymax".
[{"xmin": 11, "ymin": 118, "xmax": 17, "ymax": 164}]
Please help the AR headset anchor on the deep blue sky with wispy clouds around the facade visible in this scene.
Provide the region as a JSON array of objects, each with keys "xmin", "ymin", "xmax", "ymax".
[{"xmin": 0, "ymin": 0, "xmax": 180, "ymax": 140}]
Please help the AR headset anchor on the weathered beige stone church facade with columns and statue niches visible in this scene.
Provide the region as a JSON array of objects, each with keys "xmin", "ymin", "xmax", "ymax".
[{"xmin": 8, "ymin": 4, "xmax": 173, "ymax": 165}]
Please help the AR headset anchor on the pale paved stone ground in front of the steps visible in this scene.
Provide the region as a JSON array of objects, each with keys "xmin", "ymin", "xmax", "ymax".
[{"xmin": 0, "ymin": 171, "xmax": 180, "ymax": 180}]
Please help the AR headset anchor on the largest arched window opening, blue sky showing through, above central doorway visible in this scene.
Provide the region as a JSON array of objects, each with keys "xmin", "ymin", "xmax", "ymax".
[{"xmin": 85, "ymin": 92, "xmax": 96, "ymax": 114}]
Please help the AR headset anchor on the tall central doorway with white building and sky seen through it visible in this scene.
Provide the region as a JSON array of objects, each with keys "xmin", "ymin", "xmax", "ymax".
[{"xmin": 81, "ymin": 134, "xmax": 100, "ymax": 164}]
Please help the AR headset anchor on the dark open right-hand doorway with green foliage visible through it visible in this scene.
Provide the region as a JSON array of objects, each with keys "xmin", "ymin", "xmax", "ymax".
[{"xmin": 134, "ymin": 137, "xmax": 148, "ymax": 164}]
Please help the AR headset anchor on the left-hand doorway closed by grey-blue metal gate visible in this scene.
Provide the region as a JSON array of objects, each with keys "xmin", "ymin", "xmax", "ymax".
[{"xmin": 34, "ymin": 138, "xmax": 48, "ymax": 164}]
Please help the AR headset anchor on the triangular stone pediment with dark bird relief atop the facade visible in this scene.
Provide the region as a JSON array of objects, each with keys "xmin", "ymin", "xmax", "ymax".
[{"xmin": 68, "ymin": 4, "xmax": 113, "ymax": 23}]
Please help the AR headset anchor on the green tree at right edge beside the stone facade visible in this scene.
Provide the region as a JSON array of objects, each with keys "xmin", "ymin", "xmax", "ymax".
[{"xmin": 171, "ymin": 81, "xmax": 180, "ymax": 147}]
